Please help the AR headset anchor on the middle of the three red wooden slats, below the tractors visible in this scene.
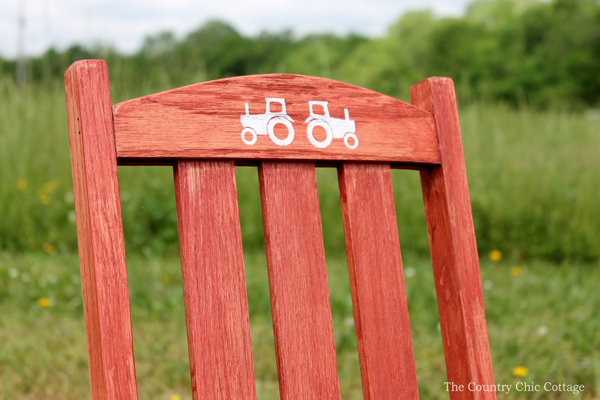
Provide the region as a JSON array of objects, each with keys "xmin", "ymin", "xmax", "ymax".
[{"xmin": 259, "ymin": 162, "xmax": 340, "ymax": 400}]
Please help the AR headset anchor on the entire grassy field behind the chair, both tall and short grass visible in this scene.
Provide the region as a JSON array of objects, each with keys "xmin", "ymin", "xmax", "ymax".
[{"xmin": 0, "ymin": 74, "xmax": 600, "ymax": 400}]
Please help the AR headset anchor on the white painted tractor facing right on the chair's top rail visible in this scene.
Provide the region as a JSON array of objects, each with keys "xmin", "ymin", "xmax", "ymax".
[{"xmin": 304, "ymin": 101, "xmax": 358, "ymax": 150}]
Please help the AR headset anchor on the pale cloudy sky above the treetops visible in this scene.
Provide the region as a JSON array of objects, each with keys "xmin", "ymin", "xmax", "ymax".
[{"xmin": 0, "ymin": 0, "xmax": 469, "ymax": 59}]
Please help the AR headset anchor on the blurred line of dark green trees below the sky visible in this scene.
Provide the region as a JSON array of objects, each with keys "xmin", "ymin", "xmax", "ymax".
[{"xmin": 0, "ymin": 0, "xmax": 600, "ymax": 107}]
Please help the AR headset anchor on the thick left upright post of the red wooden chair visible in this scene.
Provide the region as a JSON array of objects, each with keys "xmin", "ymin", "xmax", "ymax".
[{"xmin": 65, "ymin": 60, "xmax": 137, "ymax": 400}]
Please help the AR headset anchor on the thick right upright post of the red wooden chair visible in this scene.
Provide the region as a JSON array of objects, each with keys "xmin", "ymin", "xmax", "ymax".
[{"xmin": 411, "ymin": 78, "xmax": 496, "ymax": 400}]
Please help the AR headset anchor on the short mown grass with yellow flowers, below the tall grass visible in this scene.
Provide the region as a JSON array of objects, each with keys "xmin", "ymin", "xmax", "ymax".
[{"xmin": 0, "ymin": 252, "xmax": 600, "ymax": 400}]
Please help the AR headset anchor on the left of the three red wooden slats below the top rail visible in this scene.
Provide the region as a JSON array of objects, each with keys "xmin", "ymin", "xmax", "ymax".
[{"xmin": 175, "ymin": 161, "xmax": 256, "ymax": 400}]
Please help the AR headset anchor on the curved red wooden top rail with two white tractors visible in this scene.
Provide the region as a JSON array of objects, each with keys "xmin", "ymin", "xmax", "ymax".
[{"xmin": 113, "ymin": 74, "xmax": 440, "ymax": 164}]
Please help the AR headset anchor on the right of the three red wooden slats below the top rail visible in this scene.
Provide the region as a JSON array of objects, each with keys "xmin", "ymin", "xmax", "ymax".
[{"xmin": 338, "ymin": 163, "xmax": 419, "ymax": 400}]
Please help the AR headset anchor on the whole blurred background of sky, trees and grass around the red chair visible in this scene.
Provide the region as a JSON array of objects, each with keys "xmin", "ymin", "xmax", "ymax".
[{"xmin": 0, "ymin": 0, "xmax": 600, "ymax": 400}]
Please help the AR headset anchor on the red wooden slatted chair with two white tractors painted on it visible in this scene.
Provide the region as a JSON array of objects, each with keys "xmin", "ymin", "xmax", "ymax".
[{"xmin": 65, "ymin": 60, "xmax": 495, "ymax": 400}]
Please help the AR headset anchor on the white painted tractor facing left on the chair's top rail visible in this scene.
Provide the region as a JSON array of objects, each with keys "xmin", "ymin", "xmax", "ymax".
[{"xmin": 240, "ymin": 97, "xmax": 294, "ymax": 146}]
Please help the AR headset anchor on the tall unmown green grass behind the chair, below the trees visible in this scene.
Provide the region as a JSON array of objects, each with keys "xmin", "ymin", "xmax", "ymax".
[{"xmin": 0, "ymin": 79, "xmax": 600, "ymax": 262}]
